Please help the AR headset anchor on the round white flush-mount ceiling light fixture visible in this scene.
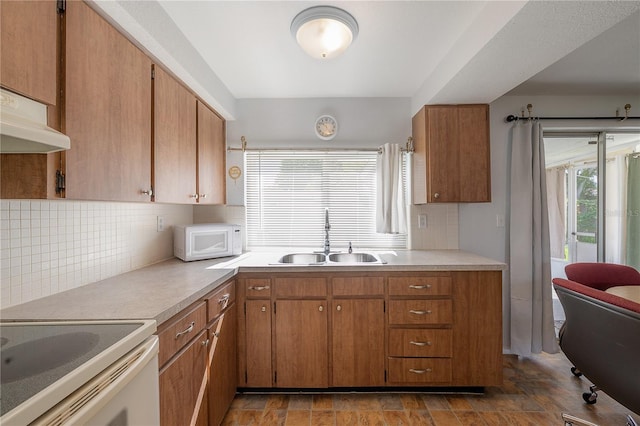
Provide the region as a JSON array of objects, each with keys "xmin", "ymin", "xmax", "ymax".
[{"xmin": 291, "ymin": 6, "xmax": 358, "ymax": 59}]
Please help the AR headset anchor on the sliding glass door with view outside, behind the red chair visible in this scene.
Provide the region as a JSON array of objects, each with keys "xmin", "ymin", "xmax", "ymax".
[{"xmin": 545, "ymin": 132, "xmax": 640, "ymax": 276}]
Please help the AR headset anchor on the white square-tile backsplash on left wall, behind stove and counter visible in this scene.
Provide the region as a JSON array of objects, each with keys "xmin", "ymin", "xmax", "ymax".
[{"xmin": 0, "ymin": 200, "xmax": 193, "ymax": 308}]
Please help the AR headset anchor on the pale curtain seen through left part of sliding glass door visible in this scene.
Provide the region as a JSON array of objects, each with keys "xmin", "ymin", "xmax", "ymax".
[{"xmin": 546, "ymin": 167, "xmax": 567, "ymax": 259}]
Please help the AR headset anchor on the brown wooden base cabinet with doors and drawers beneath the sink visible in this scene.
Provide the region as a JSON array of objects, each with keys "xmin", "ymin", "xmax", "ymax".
[{"xmin": 238, "ymin": 271, "xmax": 502, "ymax": 388}]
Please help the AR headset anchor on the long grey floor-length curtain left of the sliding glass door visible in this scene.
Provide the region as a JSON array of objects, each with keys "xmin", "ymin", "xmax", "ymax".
[{"xmin": 507, "ymin": 120, "xmax": 558, "ymax": 356}]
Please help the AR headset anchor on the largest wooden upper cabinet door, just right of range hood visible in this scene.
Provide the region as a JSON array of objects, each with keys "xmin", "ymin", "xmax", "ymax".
[{"xmin": 63, "ymin": 1, "xmax": 151, "ymax": 201}]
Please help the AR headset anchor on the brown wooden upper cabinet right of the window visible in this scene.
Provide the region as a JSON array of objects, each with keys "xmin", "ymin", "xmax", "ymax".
[{"xmin": 412, "ymin": 104, "xmax": 491, "ymax": 204}]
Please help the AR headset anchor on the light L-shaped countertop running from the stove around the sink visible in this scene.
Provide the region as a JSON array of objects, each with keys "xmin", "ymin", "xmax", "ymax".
[{"xmin": 0, "ymin": 248, "xmax": 506, "ymax": 324}]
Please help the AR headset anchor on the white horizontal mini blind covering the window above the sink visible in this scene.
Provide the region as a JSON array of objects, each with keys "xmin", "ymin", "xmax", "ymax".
[{"xmin": 245, "ymin": 151, "xmax": 407, "ymax": 250}]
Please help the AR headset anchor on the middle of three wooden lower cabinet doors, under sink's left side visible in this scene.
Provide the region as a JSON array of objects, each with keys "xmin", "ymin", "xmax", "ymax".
[{"xmin": 275, "ymin": 300, "xmax": 329, "ymax": 388}]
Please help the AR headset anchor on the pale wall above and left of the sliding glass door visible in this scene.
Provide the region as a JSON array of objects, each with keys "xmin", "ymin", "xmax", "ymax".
[{"xmin": 459, "ymin": 95, "xmax": 640, "ymax": 348}]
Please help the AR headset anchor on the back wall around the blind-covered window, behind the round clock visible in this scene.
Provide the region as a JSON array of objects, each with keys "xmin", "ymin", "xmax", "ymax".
[{"xmin": 201, "ymin": 98, "xmax": 458, "ymax": 249}]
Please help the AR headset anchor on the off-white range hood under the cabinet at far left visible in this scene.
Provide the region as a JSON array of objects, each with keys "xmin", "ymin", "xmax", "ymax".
[{"xmin": 0, "ymin": 89, "xmax": 71, "ymax": 154}]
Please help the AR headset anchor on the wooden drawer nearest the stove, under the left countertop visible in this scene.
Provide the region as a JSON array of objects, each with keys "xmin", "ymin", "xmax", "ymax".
[{"xmin": 158, "ymin": 302, "xmax": 207, "ymax": 366}]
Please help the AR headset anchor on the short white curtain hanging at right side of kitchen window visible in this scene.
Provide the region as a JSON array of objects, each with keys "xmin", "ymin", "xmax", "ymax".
[{"xmin": 376, "ymin": 143, "xmax": 407, "ymax": 234}]
